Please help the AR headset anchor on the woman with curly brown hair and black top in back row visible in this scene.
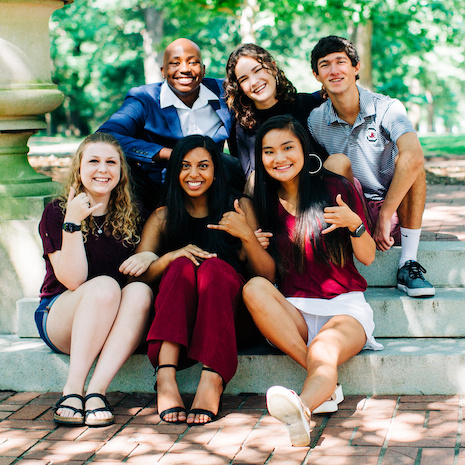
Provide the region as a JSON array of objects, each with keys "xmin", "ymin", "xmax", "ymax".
[{"xmin": 224, "ymin": 44, "xmax": 331, "ymax": 179}]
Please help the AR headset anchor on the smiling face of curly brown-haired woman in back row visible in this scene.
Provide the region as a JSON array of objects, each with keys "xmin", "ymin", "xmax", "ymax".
[{"xmin": 234, "ymin": 56, "xmax": 278, "ymax": 110}]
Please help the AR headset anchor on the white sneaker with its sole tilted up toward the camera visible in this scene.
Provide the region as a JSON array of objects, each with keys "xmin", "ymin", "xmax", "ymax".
[{"xmin": 266, "ymin": 386, "xmax": 311, "ymax": 447}]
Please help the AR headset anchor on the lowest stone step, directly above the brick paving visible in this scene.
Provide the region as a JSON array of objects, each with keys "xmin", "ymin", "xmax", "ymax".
[{"xmin": 0, "ymin": 336, "xmax": 465, "ymax": 395}]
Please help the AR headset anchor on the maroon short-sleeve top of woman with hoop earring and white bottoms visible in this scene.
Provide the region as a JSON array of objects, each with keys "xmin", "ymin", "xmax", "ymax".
[{"xmin": 277, "ymin": 177, "xmax": 368, "ymax": 299}]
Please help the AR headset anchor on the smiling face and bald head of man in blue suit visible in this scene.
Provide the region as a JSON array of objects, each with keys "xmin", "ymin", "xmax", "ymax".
[{"xmin": 161, "ymin": 39, "xmax": 205, "ymax": 106}]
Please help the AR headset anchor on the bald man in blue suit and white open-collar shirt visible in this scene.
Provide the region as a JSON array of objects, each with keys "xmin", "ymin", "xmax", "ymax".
[{"xmin": 98, "ymin": 39, "xmax": 244, "ymax": 209}]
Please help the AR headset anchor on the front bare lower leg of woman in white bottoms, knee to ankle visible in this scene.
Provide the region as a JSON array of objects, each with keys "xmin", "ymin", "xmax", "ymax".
[{"xmin": 300, "ymin": 315, "xmax": 366, "ymax": 411}]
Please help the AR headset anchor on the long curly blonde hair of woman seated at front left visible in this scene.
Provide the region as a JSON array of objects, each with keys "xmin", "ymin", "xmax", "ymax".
[{"xmin": 60, "ymin": 132, "xmax": 142, "ymax": 246}]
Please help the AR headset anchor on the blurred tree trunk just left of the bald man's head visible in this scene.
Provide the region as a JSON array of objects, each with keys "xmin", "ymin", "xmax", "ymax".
[{"xmin": 141, "ymin": 7, "xmax": 163, "ymax": 84}]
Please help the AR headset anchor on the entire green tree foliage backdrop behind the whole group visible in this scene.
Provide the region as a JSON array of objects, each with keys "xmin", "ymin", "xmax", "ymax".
[{"xmin": 51, "ymin": 0, "xmax": 465, "ymax": 133}]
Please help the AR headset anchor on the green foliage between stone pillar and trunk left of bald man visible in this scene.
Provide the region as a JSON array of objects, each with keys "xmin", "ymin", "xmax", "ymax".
[{"xmin": 50, "ymin": 0, "xmax": 143, "ymax": 134}]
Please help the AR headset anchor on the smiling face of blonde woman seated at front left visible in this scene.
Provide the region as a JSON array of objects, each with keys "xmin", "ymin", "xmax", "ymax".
[{"xmin": 80, "ymin": 142, "xmax": 121, "ymax": 199}]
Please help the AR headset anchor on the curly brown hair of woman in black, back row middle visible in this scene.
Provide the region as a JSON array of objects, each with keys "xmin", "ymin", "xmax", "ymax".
[{"xmin": 224, "ymin": 44, "xmax": 297, "ymax": 129}]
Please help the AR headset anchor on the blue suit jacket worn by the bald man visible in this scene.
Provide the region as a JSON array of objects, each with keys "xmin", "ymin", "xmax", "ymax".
[{"xmin": 98, "ymin": 78, "xmax": 231, "ymax": 182}]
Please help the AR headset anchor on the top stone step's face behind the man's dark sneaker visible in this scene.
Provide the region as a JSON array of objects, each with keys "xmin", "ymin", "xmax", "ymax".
[{"xmin": 356, "ymin": 241, "xmax": 465, "ymax": 287}]
